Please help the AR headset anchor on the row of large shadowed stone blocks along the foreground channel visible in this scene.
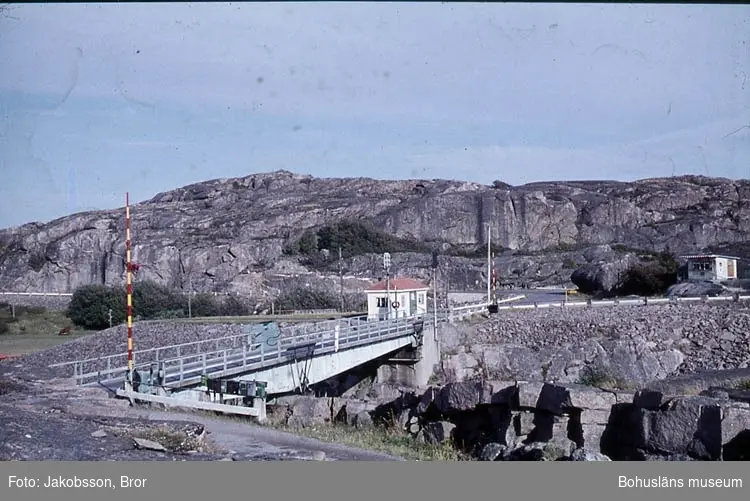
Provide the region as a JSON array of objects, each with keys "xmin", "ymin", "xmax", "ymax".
[{"xmin": 275, "ymin": 378, "xmax": 750, "ymax": 461}]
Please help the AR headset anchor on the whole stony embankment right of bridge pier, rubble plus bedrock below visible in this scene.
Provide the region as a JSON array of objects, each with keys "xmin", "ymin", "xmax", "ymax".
[{"xmin": 439, "ymin": 300, "xmax": 750, "ymax": 387}]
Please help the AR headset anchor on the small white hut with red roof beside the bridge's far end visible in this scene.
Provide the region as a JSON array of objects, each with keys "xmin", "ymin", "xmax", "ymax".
[{"xmin": 365, "ymin": 277, "xmax": 430, "ymax": 320}]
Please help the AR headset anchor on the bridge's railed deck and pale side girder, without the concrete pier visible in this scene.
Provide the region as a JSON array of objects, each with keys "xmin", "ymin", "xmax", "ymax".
[{"xmin": 51, "ymin": 303, "xmax": 494, "ymax": 393}]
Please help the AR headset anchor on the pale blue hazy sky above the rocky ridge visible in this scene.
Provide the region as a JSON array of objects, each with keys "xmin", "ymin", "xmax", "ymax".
[{"xmin": 0, "ymin": 2, "xmax": 750, "ymax": 228}]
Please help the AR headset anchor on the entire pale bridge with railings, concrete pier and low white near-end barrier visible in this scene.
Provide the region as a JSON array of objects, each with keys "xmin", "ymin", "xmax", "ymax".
[{"xmin": 51, "ymin": 297, "xmax": 520, "ymax": 420}]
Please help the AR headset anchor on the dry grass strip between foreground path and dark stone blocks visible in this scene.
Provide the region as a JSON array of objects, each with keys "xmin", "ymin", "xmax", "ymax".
[{"xmin": 273, "ymin": 425, "xmax": 472, "ymax": 461}]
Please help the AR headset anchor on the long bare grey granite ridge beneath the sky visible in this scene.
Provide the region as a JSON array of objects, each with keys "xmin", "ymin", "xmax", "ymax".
[{"xmin": 0, "ymin": 171, "xmax": 750, "ymax": 292}]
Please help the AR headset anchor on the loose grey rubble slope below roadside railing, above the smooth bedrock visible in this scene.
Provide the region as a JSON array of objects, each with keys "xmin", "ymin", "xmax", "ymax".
[{"xmin": 465, "ymin": 301, "xmax": 750, "ymax": 374}]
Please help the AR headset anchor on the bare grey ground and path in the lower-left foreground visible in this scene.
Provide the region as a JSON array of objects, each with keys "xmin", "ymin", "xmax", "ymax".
[{"xmin": 0, "ymin": 382, "xmax": 403, "ymax": 461}]
